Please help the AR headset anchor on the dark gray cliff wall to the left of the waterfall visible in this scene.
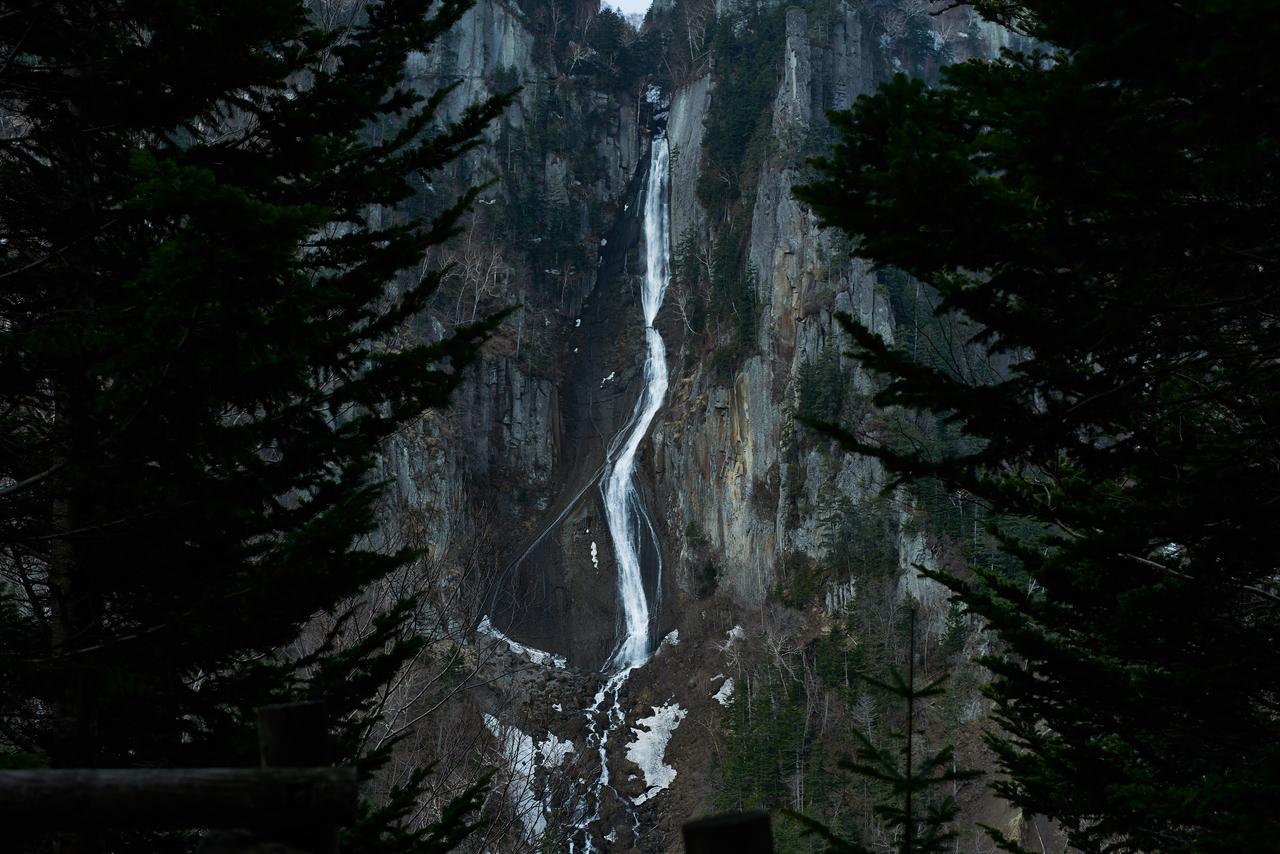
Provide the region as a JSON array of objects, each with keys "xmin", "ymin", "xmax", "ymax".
[{"xmin": 384, "ymin": 0, "xmax": 644, "ymax": 594}]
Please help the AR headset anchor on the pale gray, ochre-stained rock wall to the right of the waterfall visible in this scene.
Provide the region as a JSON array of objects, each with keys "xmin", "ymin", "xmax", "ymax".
[{"xmin": 655, "ymin": 1, "xmax": 1007, "ymax": 614}]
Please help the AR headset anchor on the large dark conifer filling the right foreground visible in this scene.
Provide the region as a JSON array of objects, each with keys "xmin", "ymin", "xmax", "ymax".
[{"xmin": 797, "ymin": 0, "xmax": 1280, "ymax": 851}]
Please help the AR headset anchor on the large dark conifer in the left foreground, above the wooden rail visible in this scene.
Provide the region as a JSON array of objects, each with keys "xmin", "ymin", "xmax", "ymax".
[{"xmin": 0, "ymin": 0, "xmax": 507, "ymax": 850}]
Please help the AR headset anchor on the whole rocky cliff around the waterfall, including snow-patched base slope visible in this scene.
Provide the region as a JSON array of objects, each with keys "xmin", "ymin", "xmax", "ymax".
[{"xmin": 373, "ymin": 0, "xmax": 1054, "ymax": 851}]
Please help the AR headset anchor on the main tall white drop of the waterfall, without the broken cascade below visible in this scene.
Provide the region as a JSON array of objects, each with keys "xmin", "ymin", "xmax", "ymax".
[{"xmin": 600, "ymin": 136, "xmax": 671, "ymax": 670}]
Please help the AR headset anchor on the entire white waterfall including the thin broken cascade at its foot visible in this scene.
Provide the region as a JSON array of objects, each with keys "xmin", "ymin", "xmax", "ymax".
[{"xmin": 570, "ymin": 136, "xmax": 671, "ymax": 851}]
